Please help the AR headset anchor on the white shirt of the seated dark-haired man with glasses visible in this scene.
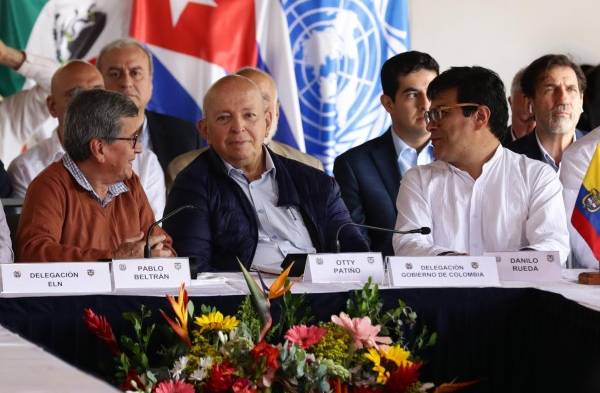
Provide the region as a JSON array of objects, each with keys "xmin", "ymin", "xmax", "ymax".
[{"xmin": 393, "ymin": 146, "xmax": 569, "ymax": 262}]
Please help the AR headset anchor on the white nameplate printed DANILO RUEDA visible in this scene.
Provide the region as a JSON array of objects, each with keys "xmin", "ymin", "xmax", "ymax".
[{"xmin": 485, "ymin": 251, "xmax": 561, "ymax": 282}]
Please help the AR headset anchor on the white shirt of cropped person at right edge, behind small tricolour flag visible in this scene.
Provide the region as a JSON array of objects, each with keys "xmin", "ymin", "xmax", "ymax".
[{"xmin": 560, "ymin": 127, "xmax": 600, "ymax": 269}]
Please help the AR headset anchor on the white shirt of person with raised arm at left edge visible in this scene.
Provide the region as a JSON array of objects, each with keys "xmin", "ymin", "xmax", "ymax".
[{"xmin": 0, "ymin": 53, "xmax": 58, "ymax": 165}]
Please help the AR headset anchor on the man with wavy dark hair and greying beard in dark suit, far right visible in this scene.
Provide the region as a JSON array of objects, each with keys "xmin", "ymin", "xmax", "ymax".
[{"xmin": 507, "ymin": 54, "xmax": 586, "ymax": 171}]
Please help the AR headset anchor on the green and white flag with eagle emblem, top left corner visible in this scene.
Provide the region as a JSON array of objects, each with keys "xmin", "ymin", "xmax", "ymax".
[{"xmin": 0, "ymin": 0, "xmax": 131, "ymax": 96}]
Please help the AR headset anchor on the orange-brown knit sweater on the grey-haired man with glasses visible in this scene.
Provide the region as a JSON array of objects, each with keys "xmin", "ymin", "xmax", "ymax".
[{"xmin": 16, "ymin": 161, "xmax": 175, "ymax": 262}]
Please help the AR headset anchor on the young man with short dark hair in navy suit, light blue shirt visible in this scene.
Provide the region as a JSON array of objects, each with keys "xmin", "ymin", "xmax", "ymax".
[{"xmin": 333, "ymin": 51, "xmax": 439, "ymax": 255}]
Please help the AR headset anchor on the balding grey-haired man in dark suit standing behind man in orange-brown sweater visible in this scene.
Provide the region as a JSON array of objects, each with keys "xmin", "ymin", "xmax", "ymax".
[{"xmin": 97, "ymin": 38, "xmax": 201, "ymax": 171}]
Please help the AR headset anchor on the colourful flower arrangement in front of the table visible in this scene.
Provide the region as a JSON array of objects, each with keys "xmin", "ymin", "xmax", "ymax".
[{"xmin": 84, "ymin": 266, "xmax": 473, "ymax": 393}]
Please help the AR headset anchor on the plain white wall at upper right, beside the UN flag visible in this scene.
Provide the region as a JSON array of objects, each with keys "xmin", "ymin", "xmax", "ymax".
[{"xmin": 408, "ymin": 0, "xmax": 600, "ymax": 94}]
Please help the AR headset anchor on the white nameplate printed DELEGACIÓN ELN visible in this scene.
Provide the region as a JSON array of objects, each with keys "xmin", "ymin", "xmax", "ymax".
[{"xmin": 0, "ymin": 262, "xmax": 112, "ymax": 294}]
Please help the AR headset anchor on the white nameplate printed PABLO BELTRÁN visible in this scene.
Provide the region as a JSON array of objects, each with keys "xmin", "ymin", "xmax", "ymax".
[{"xmin": 112, "ymin": 258, "xmax": 190, "ymax": 289}]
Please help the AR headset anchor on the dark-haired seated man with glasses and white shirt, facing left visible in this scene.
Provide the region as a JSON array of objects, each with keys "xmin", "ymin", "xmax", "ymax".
[{"xmin": 393, "ymin": 67, "xmax": 569, "ymax": 262}]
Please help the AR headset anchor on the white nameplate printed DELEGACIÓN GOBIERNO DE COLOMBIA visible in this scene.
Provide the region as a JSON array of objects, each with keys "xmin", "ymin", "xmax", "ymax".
[{"xmin": 387, "ymin": 256, "xmax": 500, "ymax": 287}]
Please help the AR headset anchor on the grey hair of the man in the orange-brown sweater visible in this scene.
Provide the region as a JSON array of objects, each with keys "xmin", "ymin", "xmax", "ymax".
[{"xmin": 64, "ymin": 89, "xmax": 138, "ymax": 162}]
